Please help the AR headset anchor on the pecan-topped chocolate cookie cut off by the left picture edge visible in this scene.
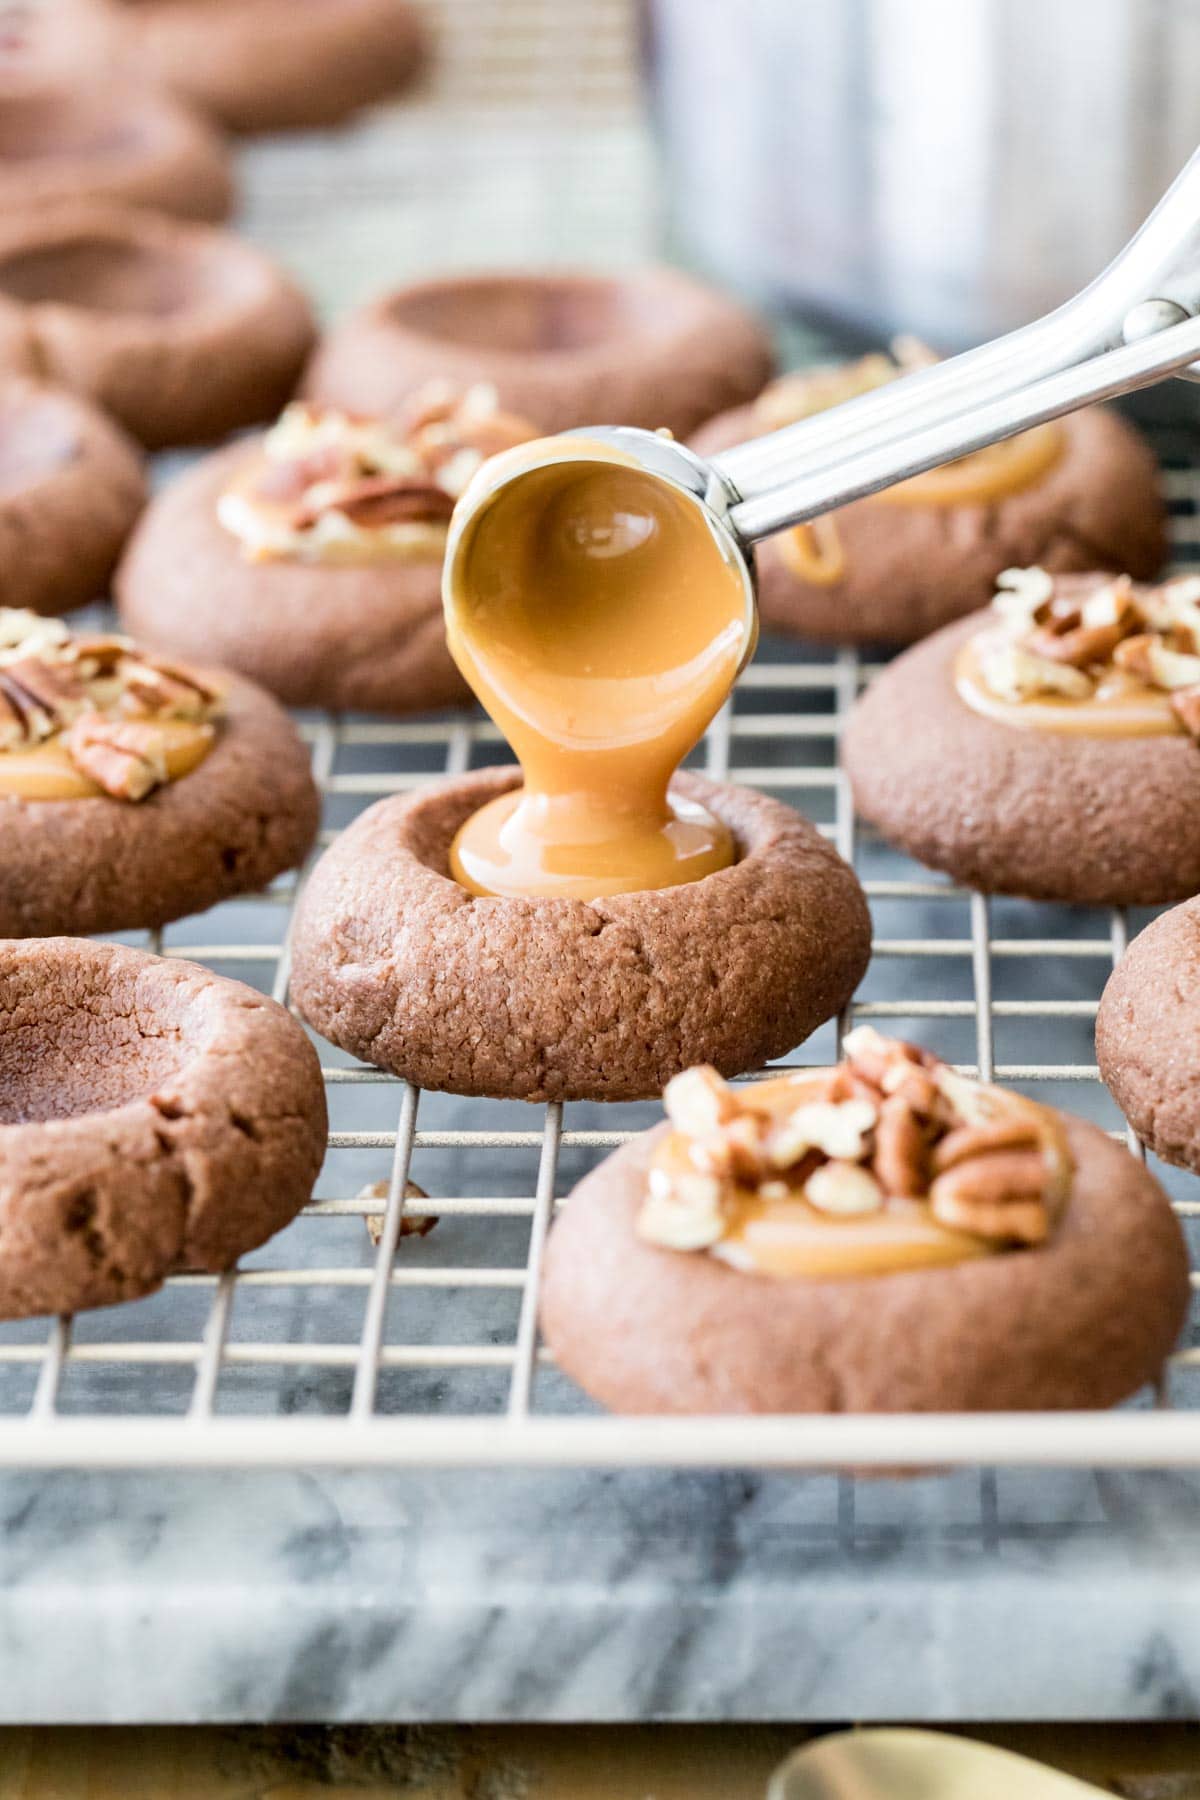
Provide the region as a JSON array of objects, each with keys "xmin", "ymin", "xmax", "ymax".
[{"xmin": 0, "ymin": 608, "xmax": 318, "ymax": 938}]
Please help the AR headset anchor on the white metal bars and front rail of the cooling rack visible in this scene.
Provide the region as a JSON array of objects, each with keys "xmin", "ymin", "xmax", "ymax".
[{"xmin": 0, "ymin": 472, "xmax": 1200, "ymax": 1469}]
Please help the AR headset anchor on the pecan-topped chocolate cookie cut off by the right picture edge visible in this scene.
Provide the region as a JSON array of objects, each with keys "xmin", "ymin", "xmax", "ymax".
[{"xmin": 842, "ymin": 569, "xmax": 1200, "ymax": 905}]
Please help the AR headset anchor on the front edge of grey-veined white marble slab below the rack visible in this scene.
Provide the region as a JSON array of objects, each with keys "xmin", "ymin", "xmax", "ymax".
[{"xmin": 0, "ymin": 1474, "xmax": 1200, "ymax": 1723}]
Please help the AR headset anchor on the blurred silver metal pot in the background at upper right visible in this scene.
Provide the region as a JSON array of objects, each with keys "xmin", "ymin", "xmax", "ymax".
[{"xmin": 642, "ymin": 0, "xmax": 1200, "ymax": 347}]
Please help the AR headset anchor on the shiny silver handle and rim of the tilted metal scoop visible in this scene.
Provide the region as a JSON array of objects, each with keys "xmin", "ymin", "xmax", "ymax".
[{"xmin": 446, "ymin": 151, "xmax": 1200, "ymax": 597}]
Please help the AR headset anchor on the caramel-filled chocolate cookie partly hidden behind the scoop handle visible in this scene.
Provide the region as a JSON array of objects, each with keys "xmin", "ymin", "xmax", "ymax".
[{"xmin": 693, "ymin": 342, "xmax": 1168, "ymax": 644}]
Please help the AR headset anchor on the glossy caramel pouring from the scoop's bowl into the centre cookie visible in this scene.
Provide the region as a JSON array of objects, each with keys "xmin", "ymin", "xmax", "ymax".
[{"xmin": 444, "ymin": 439, "xmax": 756, "ymax": 900}]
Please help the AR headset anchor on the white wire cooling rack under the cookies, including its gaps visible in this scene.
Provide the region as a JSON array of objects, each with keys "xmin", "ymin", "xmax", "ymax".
[{"xmin": 0, "ymin": 453, "xmax": 1200, "ymax": 1469}]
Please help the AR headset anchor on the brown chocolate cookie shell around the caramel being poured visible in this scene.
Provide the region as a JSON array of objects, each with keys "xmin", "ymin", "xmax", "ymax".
[{"xmin": 291, "ymin": 769, "xmax": 871, "ymax": 1100}]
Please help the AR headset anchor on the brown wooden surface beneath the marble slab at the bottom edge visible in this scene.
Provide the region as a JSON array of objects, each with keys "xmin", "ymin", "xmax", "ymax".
[{"xmin": 0, "ymin": 1724, "xmax": 1200, "ymax": 1800}]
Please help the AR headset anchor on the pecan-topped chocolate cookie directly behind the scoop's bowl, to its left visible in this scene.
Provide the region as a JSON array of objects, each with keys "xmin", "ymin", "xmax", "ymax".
[{"xmin": 117, "ymin": 383, "xmax": 534, "ymax": 715}]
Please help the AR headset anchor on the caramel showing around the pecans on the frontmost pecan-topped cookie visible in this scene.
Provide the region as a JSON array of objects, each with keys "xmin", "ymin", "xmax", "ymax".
[{"xmin": 653, "ymin": 1071, "xmax": 1067, "ymax": 1280}]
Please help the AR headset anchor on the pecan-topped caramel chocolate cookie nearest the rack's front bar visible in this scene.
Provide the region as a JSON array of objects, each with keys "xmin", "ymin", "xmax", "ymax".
[{"xmin": 542, "ymin": 1030, "xmax": 1189, "ymax": 1413}]
